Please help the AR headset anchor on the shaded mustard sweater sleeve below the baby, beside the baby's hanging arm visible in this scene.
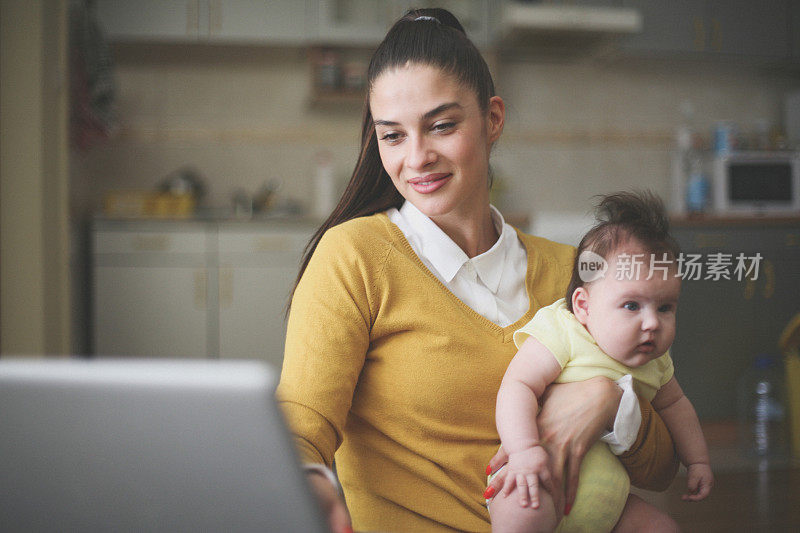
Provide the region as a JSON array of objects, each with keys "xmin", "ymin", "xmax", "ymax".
[{"xmin": 619, "ymin": 398, "xmax": 679, "ymax": 490}]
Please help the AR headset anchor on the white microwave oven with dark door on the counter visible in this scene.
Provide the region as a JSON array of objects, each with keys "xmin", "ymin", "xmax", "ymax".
[{"xmin": 712, "ymin": 152, "xmax": 800, "ymax": 214}]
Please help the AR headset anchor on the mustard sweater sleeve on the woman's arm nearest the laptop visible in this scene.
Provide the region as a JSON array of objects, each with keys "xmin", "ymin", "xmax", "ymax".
[{"xmin": 277, "ymin": 223, "xmax": 371, "ymax": 467}]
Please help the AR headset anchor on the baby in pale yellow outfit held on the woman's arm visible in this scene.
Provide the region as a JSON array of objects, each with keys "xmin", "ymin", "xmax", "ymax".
[{"xmin": 489, "ymin": 193, "xmax": 714, "ymax": 531}]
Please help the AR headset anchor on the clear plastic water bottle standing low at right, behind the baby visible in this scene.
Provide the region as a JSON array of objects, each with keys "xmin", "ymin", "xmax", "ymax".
[{"xmin": 738, "ymin": 355, "xmax": 788, "ymax": 461}]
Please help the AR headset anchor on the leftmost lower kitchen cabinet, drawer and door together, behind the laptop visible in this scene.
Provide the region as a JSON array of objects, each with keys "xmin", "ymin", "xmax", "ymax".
[{"xmin": 92, "ymin": 225, "xmax": 210, "ymax": 357}]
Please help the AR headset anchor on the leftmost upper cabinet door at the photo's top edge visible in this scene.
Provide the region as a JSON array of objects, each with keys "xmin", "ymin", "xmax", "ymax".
[{"xmin": 96, "ymin": 0, "xmax": 202, "ymax": 41}]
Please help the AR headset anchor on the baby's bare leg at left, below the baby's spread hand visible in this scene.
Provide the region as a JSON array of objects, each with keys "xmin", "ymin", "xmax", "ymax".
[{"xmin": 489, "ymin": 487, "xmax": 561, "ymax": 533}]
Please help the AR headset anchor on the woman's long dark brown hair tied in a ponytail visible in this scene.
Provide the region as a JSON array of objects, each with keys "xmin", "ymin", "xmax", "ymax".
[{"xmin": 289, "ymin": 8, "xmax": 495, "ymax": 305}]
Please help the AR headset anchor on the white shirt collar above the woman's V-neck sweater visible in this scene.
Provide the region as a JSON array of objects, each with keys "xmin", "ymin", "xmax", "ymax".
[{"xmin": 399, "ymin": 202, "xmax": 513, "ymax": 293}]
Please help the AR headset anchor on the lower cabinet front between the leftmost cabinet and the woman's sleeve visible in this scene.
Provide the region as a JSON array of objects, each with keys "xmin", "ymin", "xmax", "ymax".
[{"xmin": 218, "ymin": 227, "xmax": 313, "ymax": 368}]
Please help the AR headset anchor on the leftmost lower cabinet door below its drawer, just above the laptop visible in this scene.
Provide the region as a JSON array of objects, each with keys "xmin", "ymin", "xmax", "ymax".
[{"xmin": 94, "ymin": 265, "xmax": 208, "ymax": 358}]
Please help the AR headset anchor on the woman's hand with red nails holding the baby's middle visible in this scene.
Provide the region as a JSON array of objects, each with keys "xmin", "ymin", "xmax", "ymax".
[{"xmin": 537, "ymin": 377, "xmax": 622, "ymax": 515}]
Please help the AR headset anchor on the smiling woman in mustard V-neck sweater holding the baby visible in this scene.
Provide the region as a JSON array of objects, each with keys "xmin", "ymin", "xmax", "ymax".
[{"xmin": 278, "ymin": 9, "xmax": 676, "ymax": 531}]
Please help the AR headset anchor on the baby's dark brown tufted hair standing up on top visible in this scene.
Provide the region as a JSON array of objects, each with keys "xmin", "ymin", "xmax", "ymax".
[{"xmin": 566, "ymin": 191, "xmax": 680, "ymax": 311}]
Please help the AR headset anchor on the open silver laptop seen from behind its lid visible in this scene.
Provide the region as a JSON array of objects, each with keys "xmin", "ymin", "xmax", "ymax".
[{"xmin": 0, "ymin": 359, "xmax": 326, "ymax": 533}]
